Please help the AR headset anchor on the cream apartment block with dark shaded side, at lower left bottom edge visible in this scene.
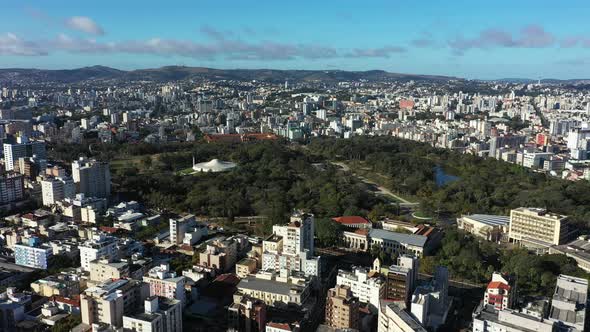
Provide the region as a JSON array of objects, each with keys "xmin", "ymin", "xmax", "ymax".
[{"xmin": 80, "ymin": 279, "xmax": 149, "ymax": 327}]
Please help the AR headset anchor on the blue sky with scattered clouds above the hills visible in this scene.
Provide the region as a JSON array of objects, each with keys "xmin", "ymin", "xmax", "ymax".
[{"xmin": 0, "ymin": 0, "xmax": 590, "ymax": 78}]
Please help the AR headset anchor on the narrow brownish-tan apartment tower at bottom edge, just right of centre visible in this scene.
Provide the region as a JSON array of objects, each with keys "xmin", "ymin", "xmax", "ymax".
[{"xmin": 326, "ymin": 286, "xmax": 359, "ymax": 329}]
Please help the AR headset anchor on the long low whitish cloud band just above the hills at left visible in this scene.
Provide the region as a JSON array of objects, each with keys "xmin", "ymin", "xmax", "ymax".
[{"xmin": 0, "ymin": 33, "xmax": 405, "ymax": 60}]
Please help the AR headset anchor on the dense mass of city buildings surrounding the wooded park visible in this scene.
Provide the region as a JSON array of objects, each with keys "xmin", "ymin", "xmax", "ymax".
[{"xmin": 0, "ymin": 74, "xmax": 590, "ymax": 332}]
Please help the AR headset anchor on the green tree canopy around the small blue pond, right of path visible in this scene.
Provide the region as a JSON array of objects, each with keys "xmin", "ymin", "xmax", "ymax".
[{"xmin": 309, "ymin": 137, "xmax": 590, "ymax": 227}]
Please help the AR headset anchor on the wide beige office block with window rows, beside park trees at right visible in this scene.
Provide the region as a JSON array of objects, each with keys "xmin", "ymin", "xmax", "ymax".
[{"xmin": 508, "ymin": 207, "xmax": 570, "ymax": 245}]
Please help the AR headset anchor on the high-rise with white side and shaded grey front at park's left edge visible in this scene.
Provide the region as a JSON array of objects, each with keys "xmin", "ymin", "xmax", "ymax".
[{"xmin": 72, "ymin": 158, "xmax": 111, "ymax": 198}]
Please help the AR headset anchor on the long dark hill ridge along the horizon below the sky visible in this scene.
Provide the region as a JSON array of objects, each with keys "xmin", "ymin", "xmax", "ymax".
[{"xmin": 0, "ymin": 66, "xmax": 457, "ymax": 83}]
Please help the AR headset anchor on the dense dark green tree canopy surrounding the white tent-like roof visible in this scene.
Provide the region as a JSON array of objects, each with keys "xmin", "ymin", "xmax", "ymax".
[{"xmin": 108, "ymin": 142, "xmax": 382, "ymax": 230}]
